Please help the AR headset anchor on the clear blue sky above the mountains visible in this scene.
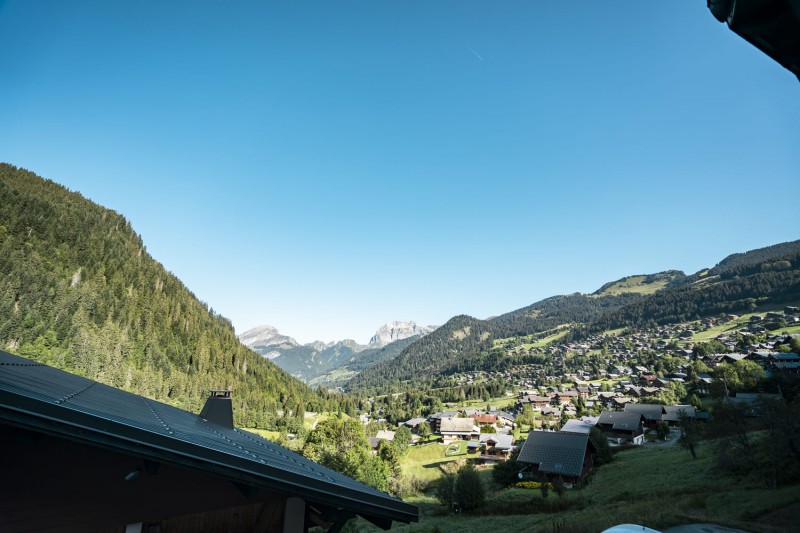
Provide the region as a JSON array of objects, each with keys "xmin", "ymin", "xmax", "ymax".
[{"xmin": 0, "ymin": 0, "xmax": 800, "ymax": 342}]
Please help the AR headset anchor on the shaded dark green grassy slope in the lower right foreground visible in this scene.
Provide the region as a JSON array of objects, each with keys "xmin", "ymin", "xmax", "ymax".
[{"xmin": 354, "ymin": 440, "xmax": 800, "ymax": 533}]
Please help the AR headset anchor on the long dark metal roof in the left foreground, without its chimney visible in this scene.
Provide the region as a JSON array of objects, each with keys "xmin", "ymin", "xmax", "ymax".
[{"xmin": 0, "ymin": 351, "xmax": 418, "ymax": 524}]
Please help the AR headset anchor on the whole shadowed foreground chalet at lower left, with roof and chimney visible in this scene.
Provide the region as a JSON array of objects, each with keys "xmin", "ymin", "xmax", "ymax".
[{"xmin": 0, "ymin": 351, "xmax": 418, "ymax": 533}]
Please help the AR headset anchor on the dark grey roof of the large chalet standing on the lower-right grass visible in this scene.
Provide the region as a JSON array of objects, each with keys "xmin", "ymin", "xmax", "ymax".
[{"xmin": 517, "ymin": 431, "xmax": 589, "ymax": 477}]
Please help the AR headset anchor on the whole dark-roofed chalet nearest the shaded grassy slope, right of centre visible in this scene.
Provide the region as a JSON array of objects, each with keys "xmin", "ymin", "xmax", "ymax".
[{"xmin": 517, "ymin": 431, "xmax": 597, "ymax": 483}]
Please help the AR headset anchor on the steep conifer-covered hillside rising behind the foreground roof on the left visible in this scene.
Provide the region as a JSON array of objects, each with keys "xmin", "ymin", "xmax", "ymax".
[{"xmin": 0, "ymin": 164, "xmax": 330, "ymax": 426}]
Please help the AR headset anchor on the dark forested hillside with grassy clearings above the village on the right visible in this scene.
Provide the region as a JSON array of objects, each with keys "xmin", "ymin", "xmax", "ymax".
[{"xmin": 348, "ymin": 241, "xmax": 800, "ymax": 391}]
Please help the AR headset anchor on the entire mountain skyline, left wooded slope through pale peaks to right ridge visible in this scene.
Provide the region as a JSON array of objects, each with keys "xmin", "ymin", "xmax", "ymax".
[{"xmin": 0, "ymin": 163, "xmax": 800, "ymax": 416}]
